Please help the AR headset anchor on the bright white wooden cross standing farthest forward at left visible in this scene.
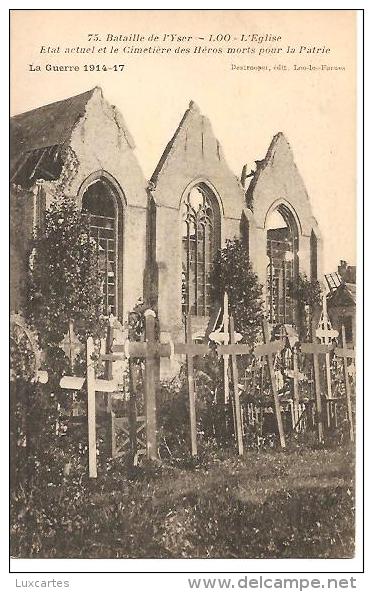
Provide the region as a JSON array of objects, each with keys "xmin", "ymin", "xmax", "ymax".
[{"xmin": 60, "ymin": 337, "xmax": 118, "ymax": 479}]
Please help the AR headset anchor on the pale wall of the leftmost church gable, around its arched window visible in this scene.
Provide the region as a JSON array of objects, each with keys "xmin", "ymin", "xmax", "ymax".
[{"xmin": 27, "ymin": 89, "xmax": 147, "ymax": 318}]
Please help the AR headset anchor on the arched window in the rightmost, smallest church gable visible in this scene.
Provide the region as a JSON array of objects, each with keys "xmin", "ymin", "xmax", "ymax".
[{"xmin": 266, "ymin": 204, "xmax": 298, "ymax": 325}]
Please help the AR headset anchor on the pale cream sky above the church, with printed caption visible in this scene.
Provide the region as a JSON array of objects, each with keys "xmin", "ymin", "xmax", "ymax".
[{"xmin": 11, "ymin": 10, "xmax": 356, "ymax": 273}]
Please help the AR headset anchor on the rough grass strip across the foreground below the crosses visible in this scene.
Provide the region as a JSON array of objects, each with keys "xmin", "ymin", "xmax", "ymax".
[{"xmin": 11, "ymin": 445, "xmax": 354, "ymax": 558}]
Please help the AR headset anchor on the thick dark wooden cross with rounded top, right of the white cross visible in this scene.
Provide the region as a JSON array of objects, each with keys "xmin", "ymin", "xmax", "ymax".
[{"xmin": 100, "ymin": 309, "xmax": 173, "ymax": 460}]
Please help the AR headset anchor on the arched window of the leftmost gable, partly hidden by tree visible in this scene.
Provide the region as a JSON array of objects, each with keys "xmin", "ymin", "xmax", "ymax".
[{"xmin": 82, "ymin": 179, "xmax": 123, "ymax": 316}]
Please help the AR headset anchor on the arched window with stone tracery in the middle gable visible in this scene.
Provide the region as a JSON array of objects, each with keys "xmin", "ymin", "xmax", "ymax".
[{"xmin": 182, "ymin": 184, "xmax": 220, "ymax": 316}]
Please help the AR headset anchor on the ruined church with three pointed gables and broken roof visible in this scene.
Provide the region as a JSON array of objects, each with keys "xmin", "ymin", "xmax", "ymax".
[{"xmin": 11, "ymin": 87, "xmax": 322, "ymax": 374}]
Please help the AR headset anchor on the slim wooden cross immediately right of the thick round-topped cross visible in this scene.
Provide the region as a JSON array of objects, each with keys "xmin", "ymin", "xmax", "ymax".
[{"xmin": 173, "ymin": 315, "xmax": 210, "ymax": 456}]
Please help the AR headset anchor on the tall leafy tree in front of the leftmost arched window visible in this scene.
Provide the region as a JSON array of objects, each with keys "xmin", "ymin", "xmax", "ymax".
[{"xmin": 26, "ymin": 198, "xmax": 103, "ymax": 358}]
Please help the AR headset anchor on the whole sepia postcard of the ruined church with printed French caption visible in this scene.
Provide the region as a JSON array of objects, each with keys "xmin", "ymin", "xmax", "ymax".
[{"xmin": 10, "ymin": 9, "xmax": 362, "ymax": 588}]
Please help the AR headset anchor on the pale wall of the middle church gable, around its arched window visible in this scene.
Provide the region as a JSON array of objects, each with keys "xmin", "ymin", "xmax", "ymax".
[{"xmin": 151, "ymin": 103, "xmax": 245, "ymax": 374}]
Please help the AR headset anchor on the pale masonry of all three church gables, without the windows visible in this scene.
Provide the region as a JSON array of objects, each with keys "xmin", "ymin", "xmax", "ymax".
[{"xmin": 11, "ymin": 88, "xmax": 323, "ymax": 375}]
